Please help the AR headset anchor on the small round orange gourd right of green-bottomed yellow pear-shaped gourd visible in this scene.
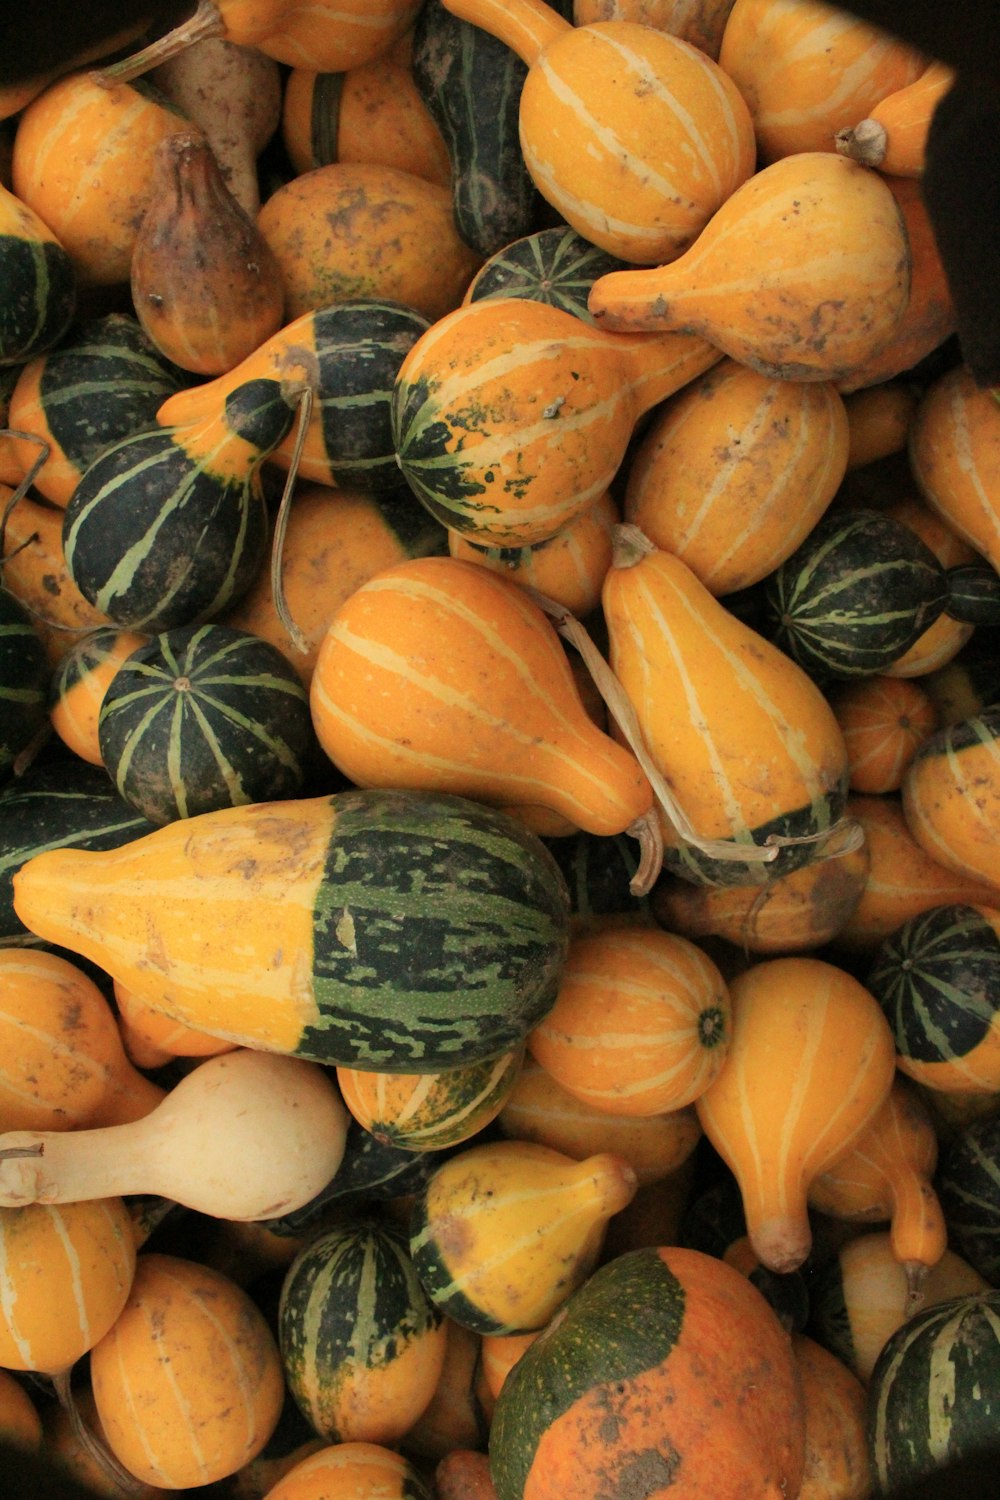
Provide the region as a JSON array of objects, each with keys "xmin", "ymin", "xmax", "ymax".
[{"xmin": 829, "ymin": 674, "xmax": 937, "ymax": 792}]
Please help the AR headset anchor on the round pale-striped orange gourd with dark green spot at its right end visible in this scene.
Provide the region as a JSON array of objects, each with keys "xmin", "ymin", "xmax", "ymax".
[{"xmin": 528, "ymin": 927, "xmax": 730, "ymax": 1115}]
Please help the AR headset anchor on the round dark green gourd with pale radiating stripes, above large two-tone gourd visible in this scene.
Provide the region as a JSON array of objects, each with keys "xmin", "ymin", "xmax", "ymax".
[{"xmin": 97, "ymin": 624, "xmax": 316, "ymax": 824}]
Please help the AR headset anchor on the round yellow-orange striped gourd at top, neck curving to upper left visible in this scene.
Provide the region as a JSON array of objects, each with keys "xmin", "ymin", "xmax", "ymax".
[{"xmin": 445, "ymin": 0, "xmax": 754, "ymax": 266}]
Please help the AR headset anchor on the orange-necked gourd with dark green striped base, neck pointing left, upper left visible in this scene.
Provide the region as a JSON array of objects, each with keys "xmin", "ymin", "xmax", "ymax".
[{"xmin": 157, "ymin": 299, "xmax": 427, "ymax": 491}]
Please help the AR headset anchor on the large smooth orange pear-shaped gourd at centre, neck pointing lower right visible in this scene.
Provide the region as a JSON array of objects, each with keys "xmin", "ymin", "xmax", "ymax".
[{"xmin": 309, "ymin": 557, "xmax": 652, "ymax": 852}]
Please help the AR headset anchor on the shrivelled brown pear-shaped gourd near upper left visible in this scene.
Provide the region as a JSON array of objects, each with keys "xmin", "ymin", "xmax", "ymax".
[{"xmin": 129, "ymin": 131, "xmax": 285, "ymax": 375}]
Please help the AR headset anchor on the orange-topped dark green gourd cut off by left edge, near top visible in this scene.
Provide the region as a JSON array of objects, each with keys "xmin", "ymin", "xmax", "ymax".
[{"xmin": 0, "ymin": 183, "xmax": 76, "ymax": 365}]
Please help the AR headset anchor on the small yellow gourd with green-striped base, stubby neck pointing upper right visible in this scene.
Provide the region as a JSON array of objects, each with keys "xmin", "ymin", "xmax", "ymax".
[{"xmin": 409, "ymin": 1140, "xmax": 637, "ymax": 1334}]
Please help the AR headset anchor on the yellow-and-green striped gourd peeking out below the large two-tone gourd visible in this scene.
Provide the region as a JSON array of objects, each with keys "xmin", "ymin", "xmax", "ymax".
[{"xmin": 337, "ymin": 1047, "xmax": 525, "ymax": 1151}]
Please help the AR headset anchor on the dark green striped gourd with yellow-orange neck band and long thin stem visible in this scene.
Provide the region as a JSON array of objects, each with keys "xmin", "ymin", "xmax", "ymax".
[{"xmin": 63, "ymin": 380, "xmax": 294, "ymax": 630}]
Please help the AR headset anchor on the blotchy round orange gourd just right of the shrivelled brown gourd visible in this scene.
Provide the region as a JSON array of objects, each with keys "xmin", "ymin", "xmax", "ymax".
[{"xmin": 256, "ymin": 162, "xmax": 481, "ymax": 321}]
